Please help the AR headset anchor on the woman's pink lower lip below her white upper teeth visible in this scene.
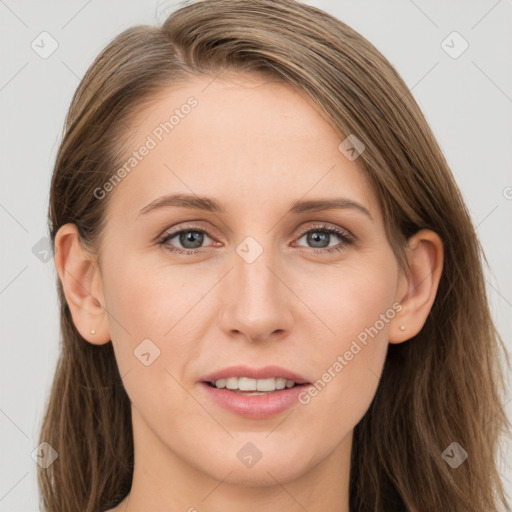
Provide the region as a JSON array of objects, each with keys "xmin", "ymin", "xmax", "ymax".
[{"xmin": 201, "ymin": 382, "xmax": 308, "ymax": 419}]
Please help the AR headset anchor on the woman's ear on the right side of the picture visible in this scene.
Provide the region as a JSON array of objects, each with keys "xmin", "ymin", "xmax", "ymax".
[{"xmin": 388, "ymin": 229, "xmax": 444, "ymax": 343}]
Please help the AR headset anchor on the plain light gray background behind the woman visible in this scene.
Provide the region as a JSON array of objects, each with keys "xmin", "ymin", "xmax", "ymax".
[{"xmin": 0, "ymin": 0, "xmax": 512, "ymax": 512}]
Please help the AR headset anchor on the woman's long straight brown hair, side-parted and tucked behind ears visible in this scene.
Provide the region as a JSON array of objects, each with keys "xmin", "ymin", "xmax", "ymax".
[{"xmin": 38, "ymin": 0, "xmax": 510, "ymax": 512}]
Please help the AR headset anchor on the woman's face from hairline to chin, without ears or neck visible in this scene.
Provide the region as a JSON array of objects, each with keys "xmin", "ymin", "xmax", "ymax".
[{"xmin": 94, "ymin": 75, "xmax": 399, "ymax": 485}]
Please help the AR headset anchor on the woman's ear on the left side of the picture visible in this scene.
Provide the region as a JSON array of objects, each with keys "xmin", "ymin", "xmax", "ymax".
[{"xmin": 55, "ymin": 224, "xmax": 110, "ymax": 345}]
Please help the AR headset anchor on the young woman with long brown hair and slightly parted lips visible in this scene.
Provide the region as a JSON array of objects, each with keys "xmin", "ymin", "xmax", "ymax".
[{"xmin": 39, "ymin": 0, "xmax": 509, "ymax": 512}]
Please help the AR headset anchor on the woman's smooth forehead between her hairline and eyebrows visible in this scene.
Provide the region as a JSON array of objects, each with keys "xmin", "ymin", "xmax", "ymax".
[{"xmin": 104, "ymin": 74, "xmax": 379, "ymax": 222}]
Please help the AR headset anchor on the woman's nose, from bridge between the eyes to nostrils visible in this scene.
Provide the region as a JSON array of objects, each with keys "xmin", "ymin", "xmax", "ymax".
[{"xmin": 220, "ymin": 239, "xmax": 297, "ymax": 342}]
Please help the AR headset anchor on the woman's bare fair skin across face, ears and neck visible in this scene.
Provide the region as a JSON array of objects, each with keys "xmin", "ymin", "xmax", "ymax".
[{"xmin": 55, "ymin": 75, "xmax": 443, "ymax": 512}]
